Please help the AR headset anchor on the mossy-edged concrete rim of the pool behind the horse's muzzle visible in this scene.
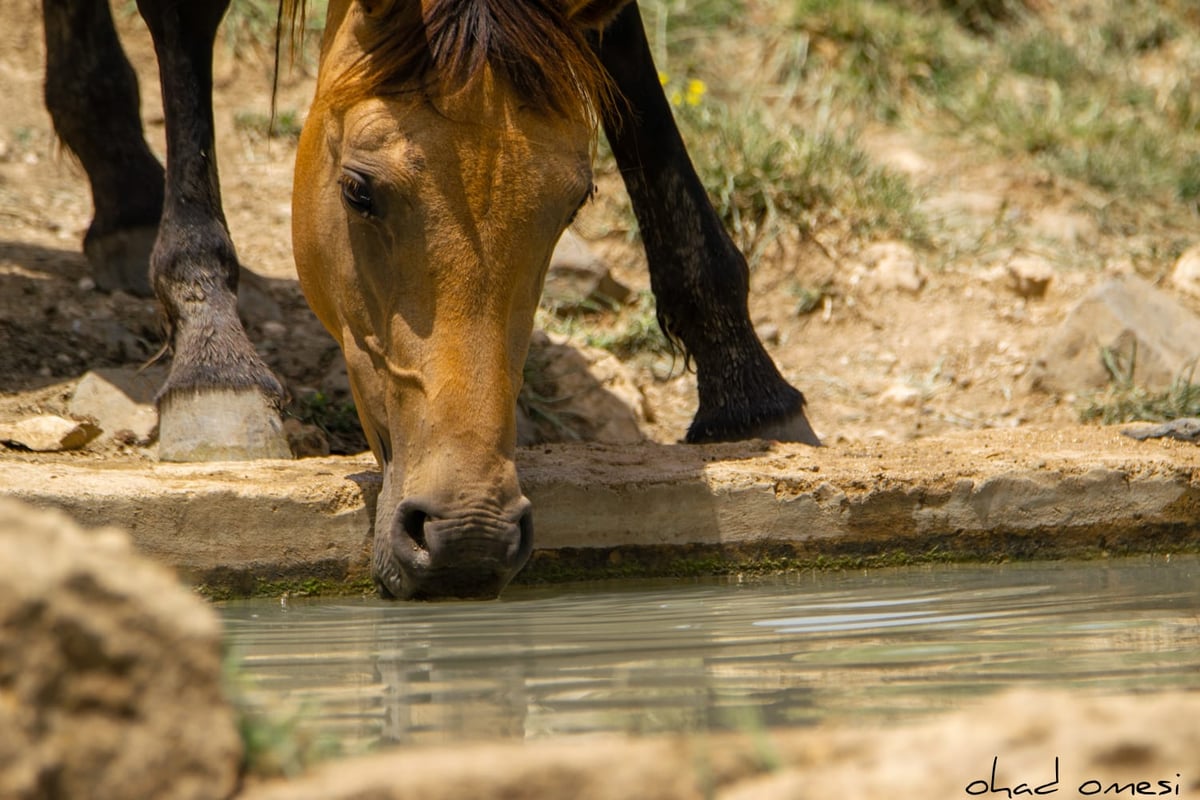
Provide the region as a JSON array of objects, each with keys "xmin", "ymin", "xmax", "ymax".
[{"xmin": 0, "ymin": 427, "xmax": 1200, "ymax": 596}]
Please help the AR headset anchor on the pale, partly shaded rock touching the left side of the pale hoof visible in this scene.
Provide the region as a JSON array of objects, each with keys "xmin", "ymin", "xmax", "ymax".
[{"xmin": 67, "ymin": 367, "xmax": 167, "ymax": 445}]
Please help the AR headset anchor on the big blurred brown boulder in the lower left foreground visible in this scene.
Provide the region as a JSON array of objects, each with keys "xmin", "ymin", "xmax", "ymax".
[{"xmin": 0, "ymin": 499, "xmax": 241, "ymax": 800}]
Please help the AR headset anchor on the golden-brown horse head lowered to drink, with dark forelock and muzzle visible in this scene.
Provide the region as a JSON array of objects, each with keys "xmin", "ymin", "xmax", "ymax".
[{"xmin": 293, "ymin": 0, "xmax": 624, "ymax": 599}]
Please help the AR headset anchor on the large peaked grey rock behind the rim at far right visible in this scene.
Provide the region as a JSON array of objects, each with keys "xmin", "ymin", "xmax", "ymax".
[{"xmin": 1028, "ymin": 276, "xmax": 1200, "ymax": 393}]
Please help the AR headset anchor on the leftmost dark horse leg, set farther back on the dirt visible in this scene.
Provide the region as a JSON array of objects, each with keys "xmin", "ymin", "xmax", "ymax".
[{"xmin": 42, "ymin": 0, "xmax": 163, "ymax": 296}]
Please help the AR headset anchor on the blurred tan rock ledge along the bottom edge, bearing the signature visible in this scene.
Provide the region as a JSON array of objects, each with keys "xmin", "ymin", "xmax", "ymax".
[{"xmin": 241, "ymin": 692, "xmax": 1200, "ymax": 800}]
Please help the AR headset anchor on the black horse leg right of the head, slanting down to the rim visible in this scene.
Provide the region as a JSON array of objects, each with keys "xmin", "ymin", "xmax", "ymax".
[{"xmin": 595, "ymin": 2, "xmax": 821, "ymax": 445}]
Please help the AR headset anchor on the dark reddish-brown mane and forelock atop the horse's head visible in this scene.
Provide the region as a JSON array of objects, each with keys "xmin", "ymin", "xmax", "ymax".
[{"xmin": 276, "ymin": 0, "xmax": 613, "ymax": 126}]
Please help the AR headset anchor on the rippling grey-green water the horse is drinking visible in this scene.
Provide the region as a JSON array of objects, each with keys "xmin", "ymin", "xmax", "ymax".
[{"xmin": 221, "ymin": 557, "xmax": 1200, "ymax": 751}]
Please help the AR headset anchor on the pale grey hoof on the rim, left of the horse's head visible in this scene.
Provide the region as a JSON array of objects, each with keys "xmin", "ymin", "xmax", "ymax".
[{"xmin": 158, "ymin": 389, "xmax": 292, "ymax": 462}]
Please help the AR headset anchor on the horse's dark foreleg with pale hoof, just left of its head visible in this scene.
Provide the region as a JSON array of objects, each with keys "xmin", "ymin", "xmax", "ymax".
[{"xmin": 138, "ymin": 0, "xmax": 290, "ymax": 461}]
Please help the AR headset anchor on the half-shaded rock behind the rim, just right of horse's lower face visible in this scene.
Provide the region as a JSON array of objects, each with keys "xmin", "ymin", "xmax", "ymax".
[{"xmin": 521, "ymin": 331, "xmax": 649, "ymax": 445}]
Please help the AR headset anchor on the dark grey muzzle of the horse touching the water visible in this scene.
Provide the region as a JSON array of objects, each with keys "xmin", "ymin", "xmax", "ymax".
[{"xmin": 374, "ymin": 497, "xmax": 533, "ymax": 600}]
